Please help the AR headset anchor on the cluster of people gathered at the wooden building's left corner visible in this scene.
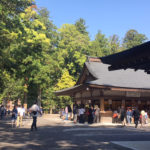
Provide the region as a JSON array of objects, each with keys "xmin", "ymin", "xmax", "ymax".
[{"xmin": 60, "ymin": 104, "xmax": 100, "ymax": 124}]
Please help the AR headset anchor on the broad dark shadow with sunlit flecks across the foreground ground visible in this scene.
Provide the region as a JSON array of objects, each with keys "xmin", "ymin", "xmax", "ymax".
[{"xmin": 0, "ymin": 120, "xmax": 150, "ymax": 150}]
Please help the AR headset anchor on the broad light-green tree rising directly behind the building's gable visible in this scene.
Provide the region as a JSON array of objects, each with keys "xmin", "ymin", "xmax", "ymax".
[{"xmin": 57, "ymin": 24, "xmax": 89, "ymax": 78}]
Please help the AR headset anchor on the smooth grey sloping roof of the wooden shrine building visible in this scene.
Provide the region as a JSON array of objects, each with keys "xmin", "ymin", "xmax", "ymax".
[{"xmin": 85, "ymin": 62, "xmax": 150, "ymax": 89}]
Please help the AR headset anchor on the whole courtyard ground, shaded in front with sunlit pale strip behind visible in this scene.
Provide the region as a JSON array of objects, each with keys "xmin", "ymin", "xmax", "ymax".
[{"xmin": 0, "ymin": 115, "xmax": 150, "ymax": 150}]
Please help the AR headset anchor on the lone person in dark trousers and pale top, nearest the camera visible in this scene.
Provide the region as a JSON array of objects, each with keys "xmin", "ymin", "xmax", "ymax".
[{"xmin": 29, "ymin": 102, "xmax": 40, "ymax": 131}]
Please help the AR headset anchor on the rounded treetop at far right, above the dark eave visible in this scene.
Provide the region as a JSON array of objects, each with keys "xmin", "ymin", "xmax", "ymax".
[{"xmin": 123, "ymin": 29, "xmax": 147, "ymax": 49}]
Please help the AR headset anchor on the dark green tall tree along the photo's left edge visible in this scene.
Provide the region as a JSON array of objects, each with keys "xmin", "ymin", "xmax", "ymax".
[{"xmin": 0, "ymin": 0, "xmax": 33, "ymax": 103}]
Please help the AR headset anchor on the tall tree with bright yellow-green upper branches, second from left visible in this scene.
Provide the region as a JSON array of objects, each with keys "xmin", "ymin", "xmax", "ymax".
[{"xmin": 17, "ymin": 7, "xmax": 55, "ymax": 105}]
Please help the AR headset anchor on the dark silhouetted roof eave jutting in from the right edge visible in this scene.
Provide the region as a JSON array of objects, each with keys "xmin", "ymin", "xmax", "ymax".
[{"xmin": 100, "ymin": 41, "xmax": 150, "ymax": 73}]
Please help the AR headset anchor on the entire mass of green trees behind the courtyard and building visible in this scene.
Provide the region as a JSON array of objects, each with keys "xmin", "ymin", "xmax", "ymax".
[{"xmin": 0, "ymin": 0, "xmax": 147, "ymax": 109}]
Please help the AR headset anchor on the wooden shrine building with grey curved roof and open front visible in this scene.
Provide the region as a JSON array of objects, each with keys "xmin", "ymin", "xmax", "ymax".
[{"xmin": 55, "ymin": 57, "xmax": 150, "ymax": 122}]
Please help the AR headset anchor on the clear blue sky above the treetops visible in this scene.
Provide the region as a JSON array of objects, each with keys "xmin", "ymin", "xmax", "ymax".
[{"xmin": 35, "ymin": 0, "xmax": 150, "ymax": 40}]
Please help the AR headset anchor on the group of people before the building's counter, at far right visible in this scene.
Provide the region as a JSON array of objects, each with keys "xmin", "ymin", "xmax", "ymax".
[{"xmin": 113, "ymin": 106, "xmax": 149, "ymax": 128}]
